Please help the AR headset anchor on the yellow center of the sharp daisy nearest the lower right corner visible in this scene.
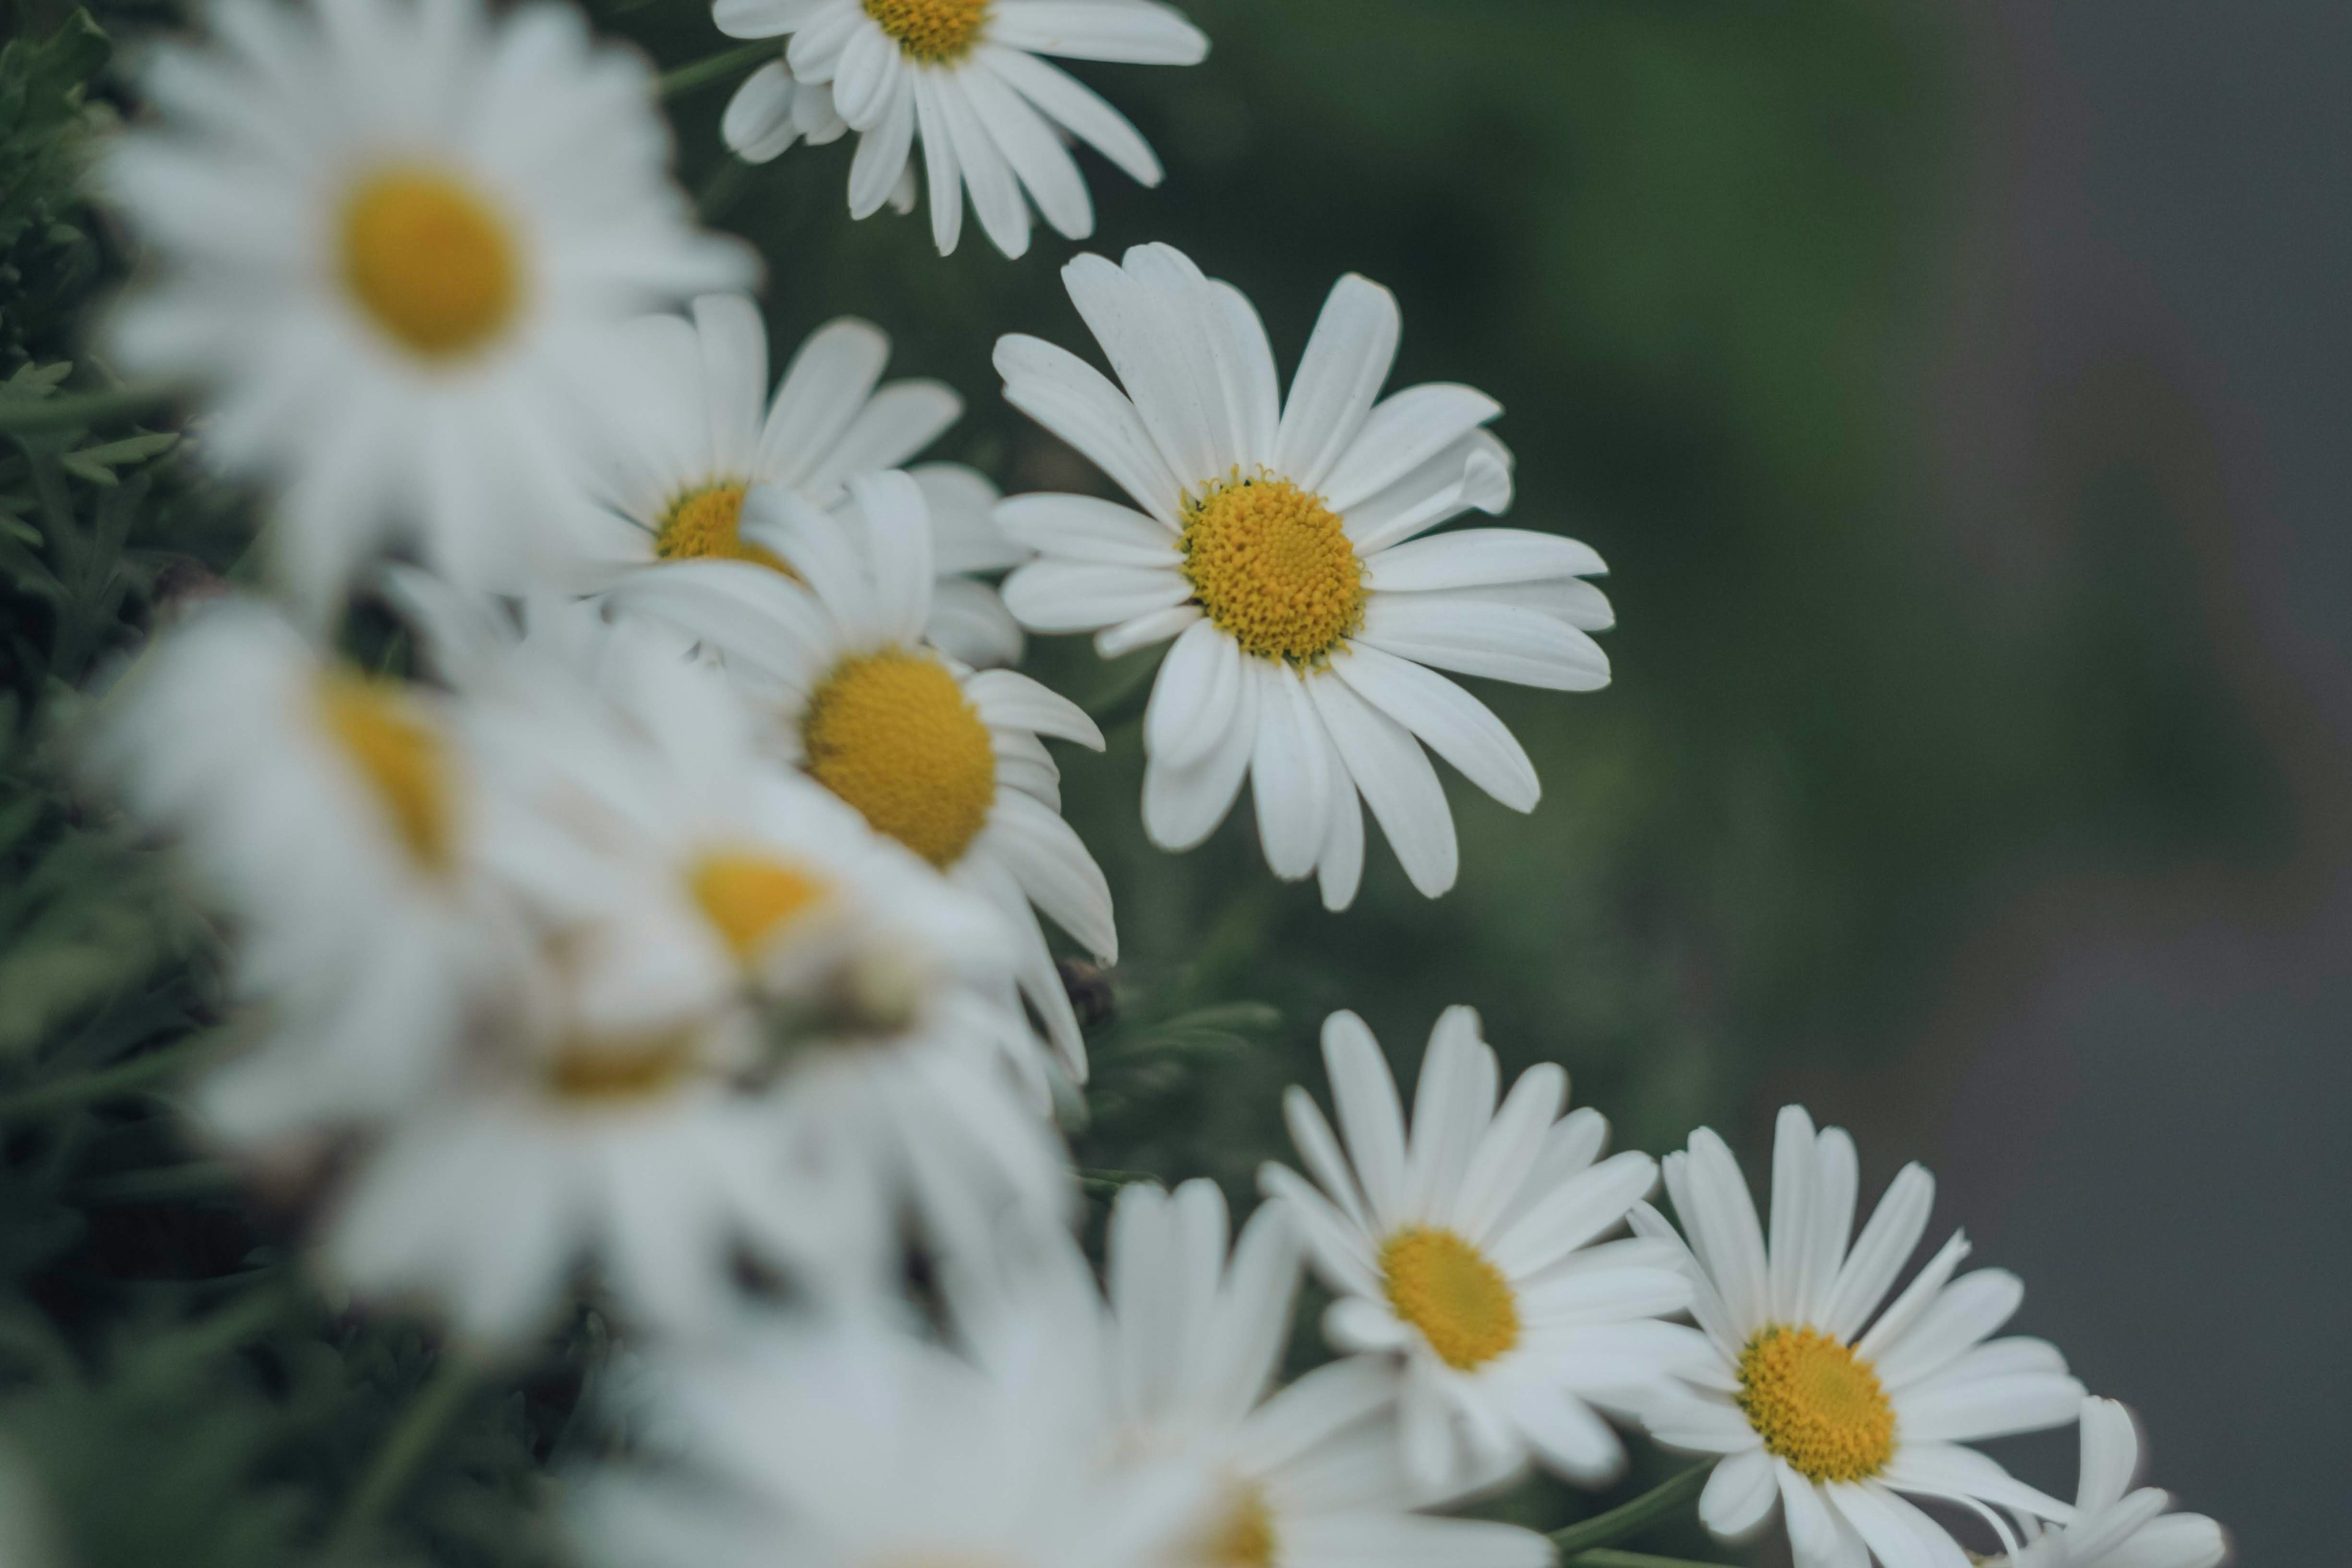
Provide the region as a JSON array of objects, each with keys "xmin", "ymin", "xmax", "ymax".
[{"xmin": 1738, "ymin": 1326, "xmax": 1896, "ymax": 1481}]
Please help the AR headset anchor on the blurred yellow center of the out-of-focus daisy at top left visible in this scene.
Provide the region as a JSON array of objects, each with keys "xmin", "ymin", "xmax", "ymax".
[{"xmin": 341, "ymin": 165, "xmax": 522, "ymax": 360}]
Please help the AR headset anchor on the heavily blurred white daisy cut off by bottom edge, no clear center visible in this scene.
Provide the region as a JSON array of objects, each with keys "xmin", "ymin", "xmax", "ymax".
[{"xmin": 574, "ymin": 1314, "xmax": 1197, "ymax": 1568}]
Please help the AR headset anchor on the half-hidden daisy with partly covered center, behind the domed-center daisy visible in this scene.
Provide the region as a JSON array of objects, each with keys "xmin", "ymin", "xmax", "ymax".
[{"xmin": 576, "ymin": 294, "xmax": 1028, "ymax": 665}]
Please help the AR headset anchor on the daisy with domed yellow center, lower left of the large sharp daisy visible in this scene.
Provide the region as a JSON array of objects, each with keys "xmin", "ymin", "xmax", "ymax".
[{"xmin": 682, "ymin": 472, "xmax": 1120, "ymax": 1082}]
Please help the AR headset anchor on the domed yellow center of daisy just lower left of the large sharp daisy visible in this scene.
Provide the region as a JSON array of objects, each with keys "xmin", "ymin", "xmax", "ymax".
[{"xmin": 800, "ymin": 649, "xmax": 997, "ymax": 870}]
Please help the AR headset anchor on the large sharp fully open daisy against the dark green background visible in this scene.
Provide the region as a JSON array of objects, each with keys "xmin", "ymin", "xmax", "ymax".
[{"xmin": 997, "ymin": 244, "xmax": 1611, "ymax": 910}]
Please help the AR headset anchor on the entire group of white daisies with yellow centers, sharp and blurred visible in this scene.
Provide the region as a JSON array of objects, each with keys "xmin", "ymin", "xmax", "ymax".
[{"xmin": 78, "ymin": 0, "xmax": 2225, "ymax": 1568}]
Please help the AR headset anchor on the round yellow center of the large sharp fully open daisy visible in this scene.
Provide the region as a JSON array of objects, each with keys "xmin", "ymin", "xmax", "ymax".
[{"xmin": 1176, "ymin": 477, "xmax": 1364, "ymax": 665}]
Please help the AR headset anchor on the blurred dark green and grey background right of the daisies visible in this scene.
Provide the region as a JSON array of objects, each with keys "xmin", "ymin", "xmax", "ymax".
[{"xmin": 649, "ymin": 0, "xmax": 2352, "ymax": 1563}]
